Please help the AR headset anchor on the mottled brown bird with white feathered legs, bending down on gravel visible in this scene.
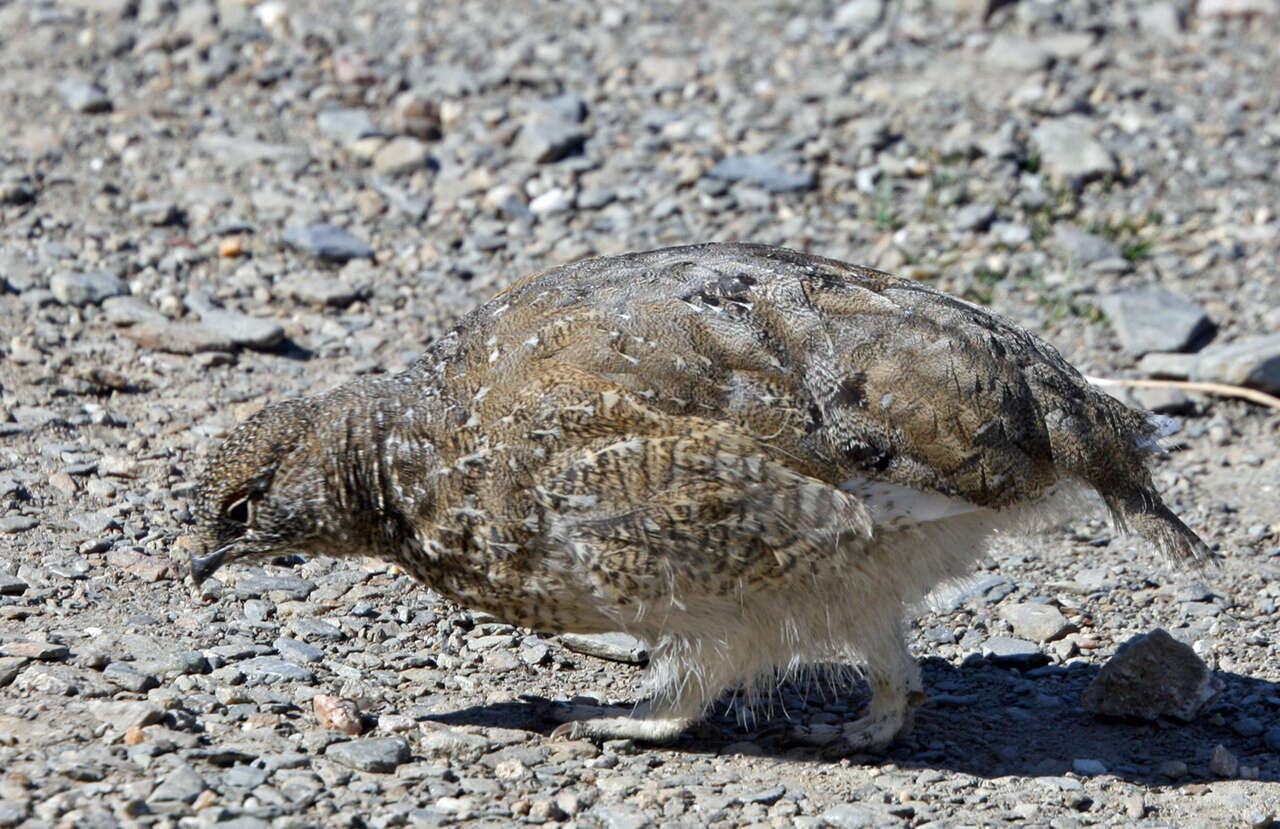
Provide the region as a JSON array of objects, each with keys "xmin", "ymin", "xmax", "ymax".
[{"xmin": 189, "ymin": 243, "xmax": 1211, "ymax": 751}]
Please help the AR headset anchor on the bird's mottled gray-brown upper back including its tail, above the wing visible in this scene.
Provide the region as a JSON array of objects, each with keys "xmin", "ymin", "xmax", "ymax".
[{"xmin": 419, "ymin": 236, "xmax": 1203, "ymax": 565}]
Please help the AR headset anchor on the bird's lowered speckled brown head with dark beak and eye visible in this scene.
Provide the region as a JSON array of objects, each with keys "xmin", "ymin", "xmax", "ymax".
[{"xmin": 191, "ymin": 400, "xmax": 333, "ymax": 585}]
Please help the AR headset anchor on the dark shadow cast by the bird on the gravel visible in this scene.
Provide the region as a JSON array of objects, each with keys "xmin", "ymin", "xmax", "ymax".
[{"xmin": 430, "ymin": 658, "xmax": 1280, "ymax": 786}]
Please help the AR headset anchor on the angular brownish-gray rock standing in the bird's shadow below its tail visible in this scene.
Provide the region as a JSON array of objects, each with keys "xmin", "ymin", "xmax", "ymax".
[{"xmin": 1080, "ymin": 628, "xmax": 1219, "ymax": 722}]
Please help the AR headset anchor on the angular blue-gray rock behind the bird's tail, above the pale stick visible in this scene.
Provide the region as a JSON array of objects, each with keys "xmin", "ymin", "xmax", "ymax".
[{"xmin": 1098, "ymin": 288, "xmax": 1213, "ymax": 357}]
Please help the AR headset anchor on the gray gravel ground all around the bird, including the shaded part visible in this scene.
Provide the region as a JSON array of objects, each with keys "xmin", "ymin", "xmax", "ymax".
[{"xmin": 0, "ymin": 0, "xmax": 1280, "ymax": 828}]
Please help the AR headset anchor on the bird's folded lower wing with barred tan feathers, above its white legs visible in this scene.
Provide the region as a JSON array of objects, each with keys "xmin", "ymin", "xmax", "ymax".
[{"xmin": 524, "ymin": 418, "xmax": 872, "ymax": 608}]
